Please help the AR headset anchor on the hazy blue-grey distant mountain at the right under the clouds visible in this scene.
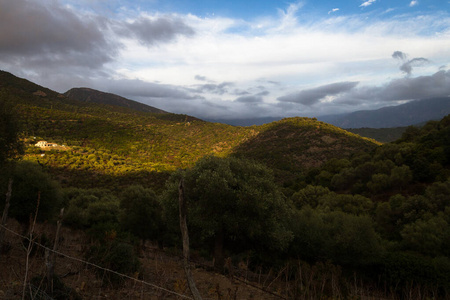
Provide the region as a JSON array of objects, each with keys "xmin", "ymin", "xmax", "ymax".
[{"xmin": 318, "ymin": 97, "xmax": 450, "ymax": 128}]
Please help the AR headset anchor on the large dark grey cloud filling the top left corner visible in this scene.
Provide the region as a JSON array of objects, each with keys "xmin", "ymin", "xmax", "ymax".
[{"xmin": 0, "ymin": 0, "xmax": 117, "ymax": 68}]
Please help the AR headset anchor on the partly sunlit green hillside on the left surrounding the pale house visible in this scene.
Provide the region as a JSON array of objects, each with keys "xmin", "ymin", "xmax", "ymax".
[{"xmin": 0, "ymin": 72, "xmax": 253, "ymax": 187}]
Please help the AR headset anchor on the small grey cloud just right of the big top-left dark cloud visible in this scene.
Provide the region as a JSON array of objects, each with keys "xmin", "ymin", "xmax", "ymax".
[{"xmin": 116, "ymin": 16, "xmax": 195, "ymax": 45}]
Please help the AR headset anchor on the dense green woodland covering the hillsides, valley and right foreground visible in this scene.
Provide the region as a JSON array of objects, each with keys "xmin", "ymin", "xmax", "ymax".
[{"xmin": 0, "ymin": 73, "xmax": 450, "ymax": 299}]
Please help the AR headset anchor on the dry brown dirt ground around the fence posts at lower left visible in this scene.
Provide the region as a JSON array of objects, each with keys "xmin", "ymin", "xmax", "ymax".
[{"xmin": 0, "ymin": 220, "xmax": 283, "ymax": 300}]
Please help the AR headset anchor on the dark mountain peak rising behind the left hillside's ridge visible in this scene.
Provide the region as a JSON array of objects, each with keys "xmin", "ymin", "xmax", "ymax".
[{"xmin": 64, "ymin": 88, "xmax": 167, "ymax": 113}]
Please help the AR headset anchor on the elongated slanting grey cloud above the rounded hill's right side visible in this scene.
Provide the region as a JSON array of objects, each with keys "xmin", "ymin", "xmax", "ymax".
[{"xmin": 277, "ymin": 81, "xmax": 358, "ymax": 106}]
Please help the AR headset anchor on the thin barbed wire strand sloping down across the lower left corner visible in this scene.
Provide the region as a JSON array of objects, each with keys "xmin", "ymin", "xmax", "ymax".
[{"xmin": 0, "ymin": 224, "xmax": 193, "ymax": 299}]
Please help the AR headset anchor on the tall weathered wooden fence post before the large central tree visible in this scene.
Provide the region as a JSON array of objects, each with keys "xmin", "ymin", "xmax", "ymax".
[{"xmin": 178, "ymin": 178, "xmax": 202, "ymax": 300}]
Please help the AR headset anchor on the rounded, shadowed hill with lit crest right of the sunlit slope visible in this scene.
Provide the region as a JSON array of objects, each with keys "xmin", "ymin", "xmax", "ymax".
[{"xmin": 234, "ymin": 118, "xmax": 376, "ymax": 172}]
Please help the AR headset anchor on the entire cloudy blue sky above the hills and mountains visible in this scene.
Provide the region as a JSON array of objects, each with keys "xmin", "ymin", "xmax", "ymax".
[{"xmin": 0, "ymin": 0, "xmax": 450, "ymax": 119}]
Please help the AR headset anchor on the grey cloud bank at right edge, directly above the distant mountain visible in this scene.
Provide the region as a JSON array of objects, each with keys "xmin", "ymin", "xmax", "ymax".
[{"xmin": 333, "ymin": 70, "xmax": 450, "ymax": 105}]
